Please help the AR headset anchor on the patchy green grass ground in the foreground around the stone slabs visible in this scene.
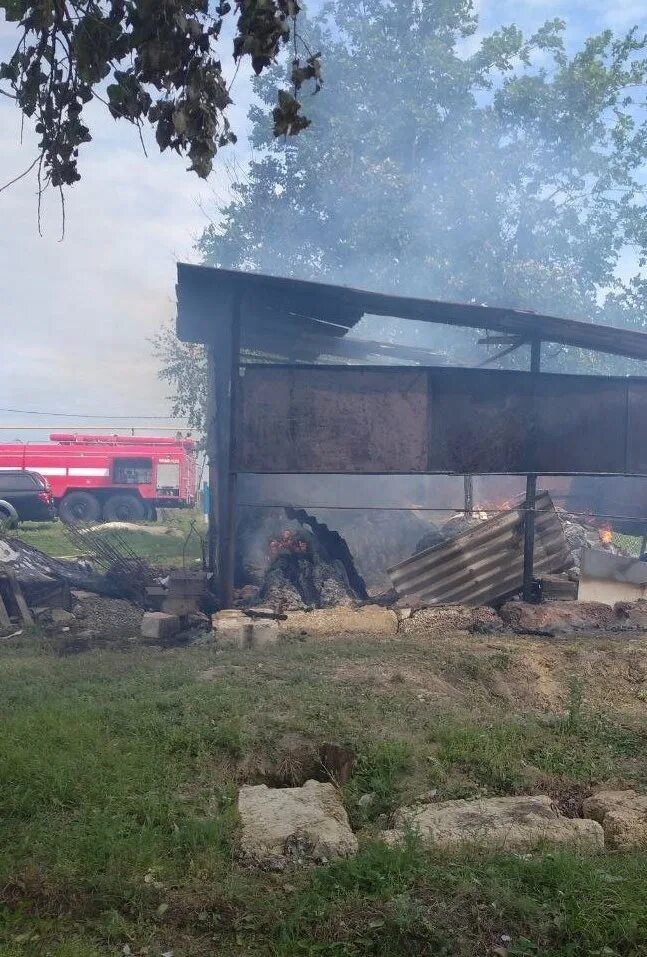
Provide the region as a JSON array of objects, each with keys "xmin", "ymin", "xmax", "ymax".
[{"xmin": 0, "ymin": 635, "xmax": 647, "ymax": 957}]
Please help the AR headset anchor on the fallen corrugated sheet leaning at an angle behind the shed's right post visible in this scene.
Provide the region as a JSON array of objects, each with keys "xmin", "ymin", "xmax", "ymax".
[{"xmin": 388, "ymin": 492, "xmax": 571, "ymax": 605}]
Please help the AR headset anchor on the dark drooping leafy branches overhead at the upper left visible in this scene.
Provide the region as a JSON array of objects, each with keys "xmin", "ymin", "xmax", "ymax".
[{"xmin": 0, "ymin": 0, "xmax": 320, "ymax": 187}]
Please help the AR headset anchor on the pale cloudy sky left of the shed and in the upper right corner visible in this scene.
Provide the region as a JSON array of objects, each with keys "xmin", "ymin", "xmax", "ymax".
[{"xmin": 0, "ymin": 0, "xmax": 647, "ymax": 441}]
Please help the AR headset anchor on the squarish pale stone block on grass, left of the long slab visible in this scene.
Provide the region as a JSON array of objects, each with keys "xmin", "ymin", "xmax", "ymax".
[{"xmin": 238, "ymin": 781, "xmax": 357, "ymax": 868}]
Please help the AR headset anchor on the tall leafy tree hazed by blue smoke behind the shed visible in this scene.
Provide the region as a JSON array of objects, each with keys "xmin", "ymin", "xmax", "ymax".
[{"xmin": 158, "ymin": 0, "xmax": 647, "ymax": 426}]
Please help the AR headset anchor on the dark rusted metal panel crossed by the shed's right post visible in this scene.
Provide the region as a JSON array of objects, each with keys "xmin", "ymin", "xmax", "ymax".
[{"xmin": 429, "ymin": 369, "xmax": 632, "ymax": 474}]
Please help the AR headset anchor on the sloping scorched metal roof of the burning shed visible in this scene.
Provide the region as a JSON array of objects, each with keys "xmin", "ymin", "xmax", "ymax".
[{"xmin": 177, "ymin": 263, "xmax": 647, "ymax": 359}]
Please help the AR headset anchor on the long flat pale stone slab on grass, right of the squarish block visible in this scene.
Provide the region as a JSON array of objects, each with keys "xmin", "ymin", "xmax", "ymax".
[{"xmin": 382, "ymin": 795, "xmax": 604, "ymax": 851}]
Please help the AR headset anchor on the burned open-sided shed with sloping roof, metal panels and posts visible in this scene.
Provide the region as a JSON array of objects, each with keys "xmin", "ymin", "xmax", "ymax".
[{"xmin": 177, "ymin": 264, "xmax": 647, "ymax": 607}]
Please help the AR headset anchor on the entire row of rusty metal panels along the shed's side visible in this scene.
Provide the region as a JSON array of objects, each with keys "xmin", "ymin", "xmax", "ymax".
[{"xmin": 235, "ymin": 365, "xmax": 647, "ymax": 475}]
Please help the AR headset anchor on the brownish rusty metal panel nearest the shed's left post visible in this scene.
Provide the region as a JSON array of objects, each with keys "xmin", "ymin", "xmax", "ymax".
[{"xmin": 235, "ymin": 366, "xmax": 429, "ymax": 473}]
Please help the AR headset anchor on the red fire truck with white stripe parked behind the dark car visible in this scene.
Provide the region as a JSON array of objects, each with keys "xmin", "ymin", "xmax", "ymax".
[{"xmin": 0, "ymin": 433, "xmax": 196, "ymax": 522}]
